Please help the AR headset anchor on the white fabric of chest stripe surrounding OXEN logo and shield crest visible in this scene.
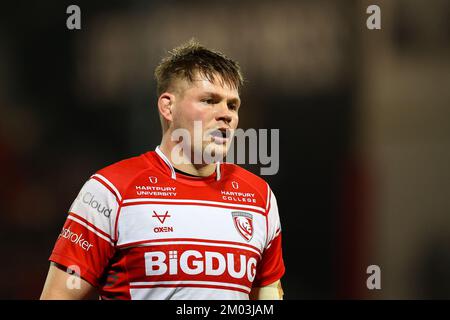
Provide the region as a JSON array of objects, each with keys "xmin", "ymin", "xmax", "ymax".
[{"xmin": 117, "ymin": 203, "xmax": 266, "ymax": 252}]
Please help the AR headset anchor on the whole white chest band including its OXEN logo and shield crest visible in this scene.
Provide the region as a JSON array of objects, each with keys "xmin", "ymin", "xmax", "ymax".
[{"xmin": 117, "ymin": 199, "xmax": 267, "ymax": 252}]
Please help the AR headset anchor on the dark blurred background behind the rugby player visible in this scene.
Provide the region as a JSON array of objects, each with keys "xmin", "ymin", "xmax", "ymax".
[{"xmin": 0, "ymin": 0, "xmax": 450, "ymax": 299}]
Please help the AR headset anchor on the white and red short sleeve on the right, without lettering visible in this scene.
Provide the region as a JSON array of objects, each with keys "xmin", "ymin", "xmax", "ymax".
[{"xmin": 253, "ymin": 188, "xmax": 285, "ymax": 287}]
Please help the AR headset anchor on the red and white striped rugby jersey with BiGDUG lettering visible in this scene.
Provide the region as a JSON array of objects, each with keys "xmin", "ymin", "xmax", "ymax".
[{"xmin": 50, "ymin": 148, "xmax": 285, "ymax": 300}]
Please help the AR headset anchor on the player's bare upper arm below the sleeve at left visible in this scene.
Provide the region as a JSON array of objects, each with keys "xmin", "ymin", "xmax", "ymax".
[{"xmin": 40, "ymin": 262, "xmax": 98, "ymax": 300}]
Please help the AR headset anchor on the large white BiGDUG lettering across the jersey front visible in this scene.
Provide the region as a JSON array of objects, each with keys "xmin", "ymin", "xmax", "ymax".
[{"xmin": 144, "ymin": 249, "xmax": 257, "ymax": 283}]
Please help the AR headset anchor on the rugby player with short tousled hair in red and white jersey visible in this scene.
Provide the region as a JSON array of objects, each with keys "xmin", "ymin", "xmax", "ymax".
[{"xmin": 41, "ymin": 40, "xmax": 285, "ymax": 300}]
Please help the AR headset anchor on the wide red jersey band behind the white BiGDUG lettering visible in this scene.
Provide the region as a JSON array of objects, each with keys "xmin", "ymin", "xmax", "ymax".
[{"xmin": 124, "ymin": 243, "xmax": 260, "ymax": 288}]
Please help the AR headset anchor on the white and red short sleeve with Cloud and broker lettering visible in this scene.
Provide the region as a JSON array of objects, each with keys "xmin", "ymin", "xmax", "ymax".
[{"xmin": 49, "ymin": 175, "xmax": 120, "ymax": 287}]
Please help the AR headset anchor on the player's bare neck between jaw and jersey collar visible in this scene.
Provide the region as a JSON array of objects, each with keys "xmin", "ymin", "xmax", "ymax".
[{"xmin": 159, "ymin": 130, "xmax": 216, "ymax": 177}]
